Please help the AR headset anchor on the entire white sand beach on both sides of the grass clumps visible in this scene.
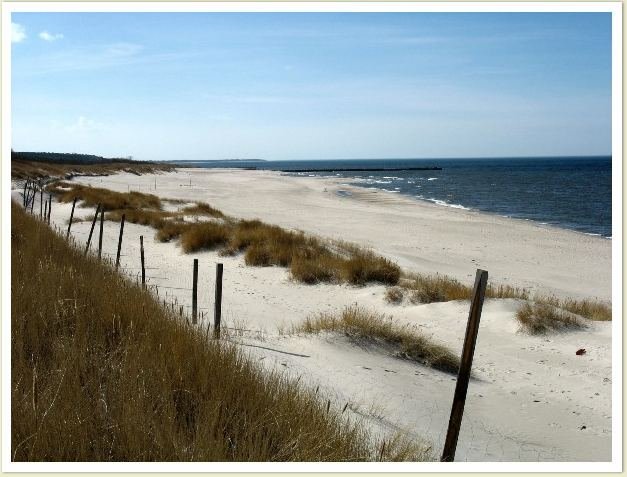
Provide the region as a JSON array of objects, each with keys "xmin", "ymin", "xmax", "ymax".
[{"xmin": 14, "ymin": 170, "xmax": 612, "ymax": 461}]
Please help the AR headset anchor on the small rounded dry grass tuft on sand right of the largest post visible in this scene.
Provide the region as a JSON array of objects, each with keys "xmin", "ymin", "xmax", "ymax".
[{"xmin": 516, "ymin": 302, "xmax": 587, "ymax": 335}]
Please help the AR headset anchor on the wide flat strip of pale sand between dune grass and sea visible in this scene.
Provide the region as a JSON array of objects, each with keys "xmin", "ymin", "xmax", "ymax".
[{"xmin": 72, "ymin": 169, "xmax": 611, "ymax": 301}]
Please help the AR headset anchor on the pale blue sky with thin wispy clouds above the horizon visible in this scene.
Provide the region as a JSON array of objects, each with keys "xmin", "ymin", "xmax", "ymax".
[{"xmin": 11, "ymin": 13, "xmax": 611, "ymax": 160}]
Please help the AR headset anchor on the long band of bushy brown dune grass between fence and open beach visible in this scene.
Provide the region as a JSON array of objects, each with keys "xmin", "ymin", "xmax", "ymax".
[{"xmin": 48, "ymin": 181, "xmax": 401, "ymax": 285}]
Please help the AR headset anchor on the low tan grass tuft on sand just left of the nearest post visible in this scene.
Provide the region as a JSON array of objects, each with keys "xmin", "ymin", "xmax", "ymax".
[{"xmin": 292, "ymin": 306, "xmax": 459, "ymax": 373}]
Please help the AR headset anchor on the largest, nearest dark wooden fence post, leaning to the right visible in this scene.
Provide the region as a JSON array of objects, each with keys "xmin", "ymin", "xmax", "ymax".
[{"xmin": 440, "ymin": 269, "xmax": 488, "ymax": 462}]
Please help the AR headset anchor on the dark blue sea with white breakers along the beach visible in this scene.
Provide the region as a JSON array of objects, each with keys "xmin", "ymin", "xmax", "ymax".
[{"xmin": 172, "ymin": 156, "xmax": 612, "ymax": 239}]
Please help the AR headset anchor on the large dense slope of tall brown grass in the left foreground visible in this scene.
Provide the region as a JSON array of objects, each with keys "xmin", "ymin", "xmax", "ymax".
[{"xmin": 10, "ymin": 204, "xmax": 426, "ymax": 462}]
